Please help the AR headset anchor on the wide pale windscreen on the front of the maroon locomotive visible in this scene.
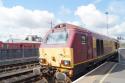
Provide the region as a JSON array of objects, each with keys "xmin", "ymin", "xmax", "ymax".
[{"xmin": 46, "ymin": 30, "xmax": 68, "ymax": 44}]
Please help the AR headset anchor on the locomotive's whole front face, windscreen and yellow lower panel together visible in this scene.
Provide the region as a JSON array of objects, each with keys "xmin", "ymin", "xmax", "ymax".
[{"xmin": 39, "ymin": 24, "xmax": 73, "ymax": 77}]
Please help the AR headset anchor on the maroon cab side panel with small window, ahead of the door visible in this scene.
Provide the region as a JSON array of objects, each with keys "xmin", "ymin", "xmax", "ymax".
[{"xmin": 73, "ymin": 31, "xmax": 88, "ymax": 63}]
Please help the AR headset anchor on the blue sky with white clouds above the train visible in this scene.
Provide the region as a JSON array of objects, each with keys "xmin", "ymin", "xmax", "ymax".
[{"xmin": 0, "ymin": 0, "xmax": 125, "ymax": 41}]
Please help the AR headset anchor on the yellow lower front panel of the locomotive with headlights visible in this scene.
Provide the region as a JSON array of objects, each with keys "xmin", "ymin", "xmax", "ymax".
[{"xmin": 39, "ymin": 48, "xmax": 72, "ymax": 67}]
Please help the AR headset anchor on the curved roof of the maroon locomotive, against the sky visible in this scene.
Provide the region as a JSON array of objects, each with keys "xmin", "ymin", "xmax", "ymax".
[{"xmin": 53, "ymin": 23, "xmax": 117, "ymax": 41}]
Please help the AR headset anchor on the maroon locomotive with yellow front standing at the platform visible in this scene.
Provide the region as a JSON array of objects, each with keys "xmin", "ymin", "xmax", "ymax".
[{"xmin": 39, "ymin": 23, "xmax": 119, "ymax": 80}]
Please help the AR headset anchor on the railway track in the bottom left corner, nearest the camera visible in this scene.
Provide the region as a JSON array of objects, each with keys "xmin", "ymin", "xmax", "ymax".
[{"xmin": 0, "ymin": 68, "xmax": 39, "ymax": 83}]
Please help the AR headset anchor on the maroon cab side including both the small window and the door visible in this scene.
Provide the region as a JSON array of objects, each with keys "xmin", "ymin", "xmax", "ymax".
[{"xmin": 73, "ymin": 31, "xmax": 92, "ymax": 63}]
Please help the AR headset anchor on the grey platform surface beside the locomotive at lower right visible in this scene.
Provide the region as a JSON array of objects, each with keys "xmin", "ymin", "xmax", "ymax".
[{"xmin": 73, "ymin": 62, "xmax": 125, "ymax": 83}]
